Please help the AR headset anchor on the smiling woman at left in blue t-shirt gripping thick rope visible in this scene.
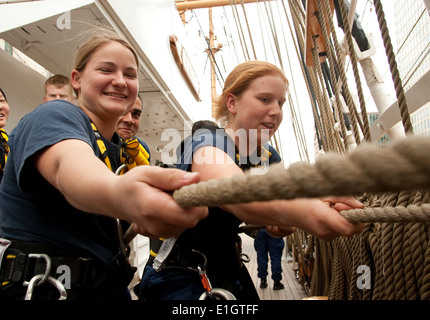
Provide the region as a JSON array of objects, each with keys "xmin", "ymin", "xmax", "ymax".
[{"xmin": 0, "ymin": 28, "xmax": 208, "ymax": 300}]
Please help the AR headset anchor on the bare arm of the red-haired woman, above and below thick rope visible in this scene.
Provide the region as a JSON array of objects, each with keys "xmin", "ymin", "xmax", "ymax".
[{"xmin": 192, "ymin": 147, "xmax": 362, "ymax": 240}]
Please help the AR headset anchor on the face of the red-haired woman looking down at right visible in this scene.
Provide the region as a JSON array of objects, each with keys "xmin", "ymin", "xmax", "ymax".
[{"xmin": 226, "ymin": 74, "xmax": 287, "ymax": 145}]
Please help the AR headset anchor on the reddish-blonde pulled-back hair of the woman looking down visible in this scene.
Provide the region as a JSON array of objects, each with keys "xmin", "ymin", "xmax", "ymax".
[{"xmin": 213, "ymin": 60, "xmax": 288, "ymax": 122}]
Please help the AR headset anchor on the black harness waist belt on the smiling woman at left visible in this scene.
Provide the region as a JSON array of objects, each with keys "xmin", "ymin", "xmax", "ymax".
[{"xmin": 0, "ymin": 240, "xmax": 135, "ymax": 290}]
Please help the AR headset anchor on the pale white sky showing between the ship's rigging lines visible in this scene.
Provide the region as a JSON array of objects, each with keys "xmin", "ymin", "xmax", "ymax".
[{"xmin": 181, "ymin": 0, "xmax": 395, "ymax": 166}]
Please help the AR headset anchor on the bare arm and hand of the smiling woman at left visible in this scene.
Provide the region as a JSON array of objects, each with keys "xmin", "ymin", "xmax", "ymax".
[{"xmin": 34, "ymin": 139, "xmax": 207, "ymax": 237}]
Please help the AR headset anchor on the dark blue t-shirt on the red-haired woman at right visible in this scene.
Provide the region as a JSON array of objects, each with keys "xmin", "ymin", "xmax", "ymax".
[{"xmin": 177, "ymin": 128, "xmax": 281, "ymax": 277}]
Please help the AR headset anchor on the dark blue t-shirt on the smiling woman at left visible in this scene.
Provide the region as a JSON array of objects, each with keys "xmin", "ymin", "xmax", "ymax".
[{"xmin": 0, "ymin": 100, "xmax": 126, "ymax": 264}]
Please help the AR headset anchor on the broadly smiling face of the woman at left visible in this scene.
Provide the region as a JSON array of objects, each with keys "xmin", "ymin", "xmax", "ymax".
[{"xmin": 71, "ymin": 41, "xmax": 138, "ymax": 134}]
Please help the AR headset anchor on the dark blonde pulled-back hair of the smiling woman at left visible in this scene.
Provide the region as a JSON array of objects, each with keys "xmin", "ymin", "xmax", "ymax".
[{"xmin": 73, "ymin": 27, "xmax": 140, "ymax": 97}]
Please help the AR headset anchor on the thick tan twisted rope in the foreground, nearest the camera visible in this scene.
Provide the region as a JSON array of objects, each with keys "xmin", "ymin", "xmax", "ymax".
[{"xmin": 173, "ymin": 137, "xmax": 430, "ymax": 208}]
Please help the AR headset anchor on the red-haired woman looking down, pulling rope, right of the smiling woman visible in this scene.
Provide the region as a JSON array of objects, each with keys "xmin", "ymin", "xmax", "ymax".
[{"xmin": 139, "ymin": 61, "xmax": 363, "ymax": 300}]
